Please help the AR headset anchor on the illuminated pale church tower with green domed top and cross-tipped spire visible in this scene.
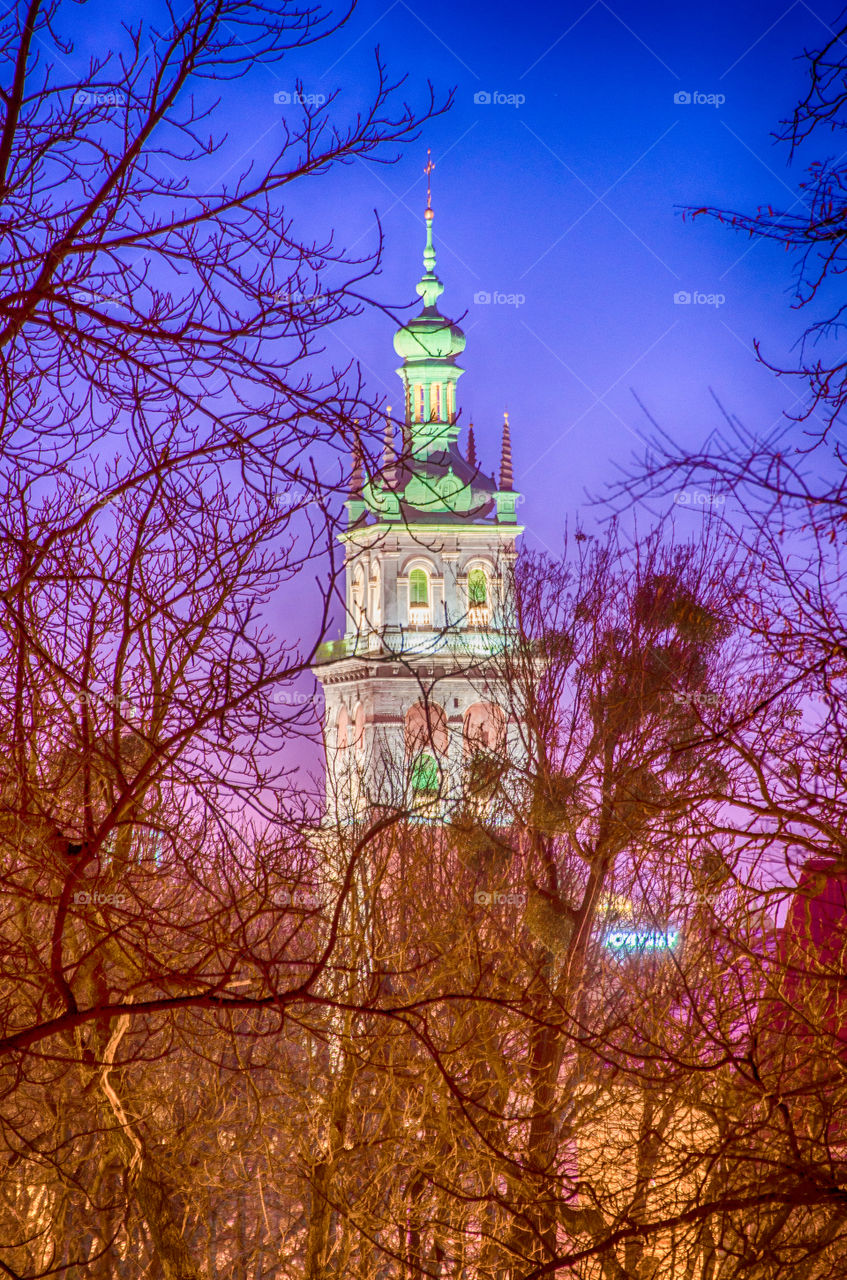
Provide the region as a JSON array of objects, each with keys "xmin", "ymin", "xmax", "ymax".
[{"xmin": 315, "ymin": 163, "xmax": 522, "ymax": 822}]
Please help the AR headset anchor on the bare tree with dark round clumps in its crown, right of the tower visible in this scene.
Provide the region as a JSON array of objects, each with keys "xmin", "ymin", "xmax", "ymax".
[{"xmin": 285, "ymin": 524, "xmax": 808, "ymax": 1280}]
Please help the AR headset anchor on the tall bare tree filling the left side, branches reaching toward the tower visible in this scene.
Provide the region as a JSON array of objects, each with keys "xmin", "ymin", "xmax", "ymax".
[{"xmin": 0, "ymin": 0, "xmax": 450, "ymax": 1280}]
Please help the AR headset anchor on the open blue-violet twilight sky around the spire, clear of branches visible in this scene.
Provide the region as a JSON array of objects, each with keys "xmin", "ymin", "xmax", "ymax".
[{"xmin": 263, "ymin": 0, "xmax": 835, "ymax": 548}]
